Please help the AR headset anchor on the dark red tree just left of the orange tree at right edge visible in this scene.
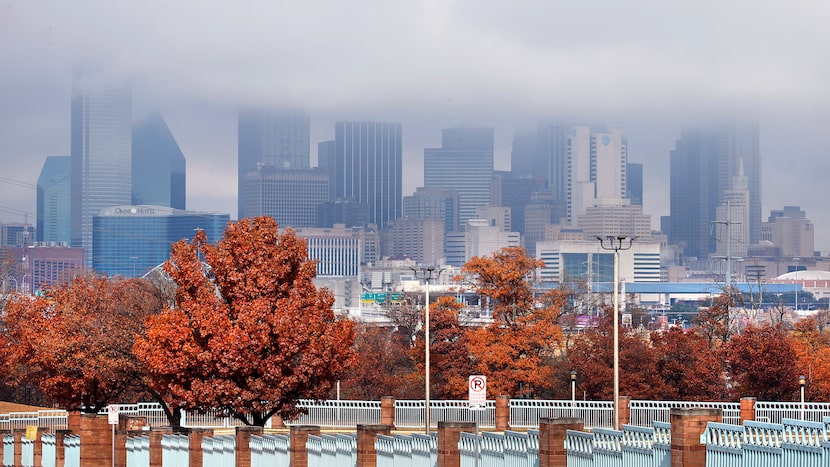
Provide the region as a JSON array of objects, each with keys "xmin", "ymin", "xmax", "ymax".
[{"xmin": 723, "ymin": 325, "xmax": 799, "ymax": 401}]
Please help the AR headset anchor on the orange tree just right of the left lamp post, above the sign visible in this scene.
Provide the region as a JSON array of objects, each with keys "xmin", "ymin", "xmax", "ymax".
[{"xmin": 462, "ymin": 247, "xmax": 565, "ymax": 395}]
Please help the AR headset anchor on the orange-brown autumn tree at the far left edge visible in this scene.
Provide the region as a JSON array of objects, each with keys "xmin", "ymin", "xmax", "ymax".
[{"xmin": 4, "ymin": 276, "xmax": 163, "ymax": 413}]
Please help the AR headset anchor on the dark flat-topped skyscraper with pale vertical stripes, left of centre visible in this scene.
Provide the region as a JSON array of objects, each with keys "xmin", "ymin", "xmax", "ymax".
[{"xmin": 329, "ymin": 121, "xmax": 403, "ymax": 229}]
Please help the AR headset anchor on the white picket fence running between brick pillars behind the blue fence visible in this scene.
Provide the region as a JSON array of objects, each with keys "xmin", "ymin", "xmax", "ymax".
[{"xmin": 6, "ymin": 399, "xmax": 830, "ymax": 432}]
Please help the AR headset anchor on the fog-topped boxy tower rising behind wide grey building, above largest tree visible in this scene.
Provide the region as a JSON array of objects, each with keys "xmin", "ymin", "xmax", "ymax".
[{"xmin": 238, "ymin": 109, "xmax": 311, "ymax": 218}]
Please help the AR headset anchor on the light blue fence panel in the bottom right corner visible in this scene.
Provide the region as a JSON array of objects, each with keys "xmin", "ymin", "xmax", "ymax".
[{"xmin": 782, "ymin": 418, "xmax": 830, "ymax": 467}]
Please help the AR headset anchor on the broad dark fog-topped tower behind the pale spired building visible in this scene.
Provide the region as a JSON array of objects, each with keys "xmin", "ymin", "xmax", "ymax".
[{"xmin": 668, "ymin": 124, "xmax": 761, "ymax": 258}]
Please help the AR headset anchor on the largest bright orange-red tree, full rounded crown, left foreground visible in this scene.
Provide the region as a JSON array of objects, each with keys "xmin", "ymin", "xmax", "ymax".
[{"xmin": 135, "ymin": 216, "xmax": 354, "ymax": 426}]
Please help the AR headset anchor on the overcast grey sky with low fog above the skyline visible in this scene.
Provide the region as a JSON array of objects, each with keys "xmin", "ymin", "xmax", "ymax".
[{"xmin": 0, "ymin": 0, "xmax": 830, "ymax": 254}]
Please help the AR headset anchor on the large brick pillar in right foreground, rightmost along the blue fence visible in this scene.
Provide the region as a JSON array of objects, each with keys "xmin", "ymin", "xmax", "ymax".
[{"xmin": 669, "ymin": 408, "xmax": 721, "ymax": 467}]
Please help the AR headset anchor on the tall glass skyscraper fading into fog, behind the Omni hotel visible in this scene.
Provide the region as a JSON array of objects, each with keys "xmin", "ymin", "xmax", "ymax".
[{"xmin": 70, "ymin": 70, "xmax": 132, "ymax": 266}]
